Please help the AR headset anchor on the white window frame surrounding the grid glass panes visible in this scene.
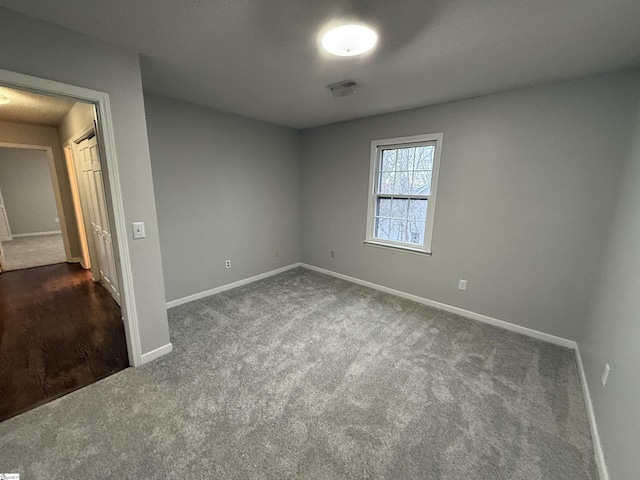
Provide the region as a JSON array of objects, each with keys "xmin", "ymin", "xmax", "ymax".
[{"xmin": 364, "ymin": 132, "xmax": 443, "ymax": 255}]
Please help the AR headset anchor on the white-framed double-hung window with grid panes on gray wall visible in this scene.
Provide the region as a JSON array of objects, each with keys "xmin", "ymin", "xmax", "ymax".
[{"xmin": 365, "ymin": 133, "xmax": 442, "ymax": 254}]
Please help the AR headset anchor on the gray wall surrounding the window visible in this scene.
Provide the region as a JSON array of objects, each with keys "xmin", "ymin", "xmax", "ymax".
[{"xmin": 301, "ymin": 72, "xmax": 639, "ymax": 340}]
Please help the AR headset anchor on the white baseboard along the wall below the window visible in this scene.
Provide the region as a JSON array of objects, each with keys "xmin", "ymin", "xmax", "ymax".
[{"xmin": 300, "ymin": 263, "xmax": 578, "ymax": 350}]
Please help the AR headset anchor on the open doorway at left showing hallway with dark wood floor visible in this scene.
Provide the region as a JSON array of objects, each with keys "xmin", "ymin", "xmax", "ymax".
[{"xmin": 0, "ymin": 82, "xmax": 130, "ymax": 421}]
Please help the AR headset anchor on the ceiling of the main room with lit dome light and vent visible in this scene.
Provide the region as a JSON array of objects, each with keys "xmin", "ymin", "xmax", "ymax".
[{"xmin": 0, "ymin": 0, "xmax": 640, "ymax": 128}]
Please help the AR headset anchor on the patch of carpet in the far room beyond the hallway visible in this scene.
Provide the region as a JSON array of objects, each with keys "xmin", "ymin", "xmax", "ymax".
[{"xmin": 2, "ymin": 233, "xmax": 67, "ymax": 271}]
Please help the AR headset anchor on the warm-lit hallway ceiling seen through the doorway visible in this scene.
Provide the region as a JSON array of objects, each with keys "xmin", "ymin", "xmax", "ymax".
[{"xmin": 0, "ymin": 87, "xmax": 75, "ymax": 127}]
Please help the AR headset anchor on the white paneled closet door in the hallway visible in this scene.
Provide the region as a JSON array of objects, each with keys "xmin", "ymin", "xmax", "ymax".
[{"xmin": 77, "ymin": 136, "xmax": 120, "ymax": 303}]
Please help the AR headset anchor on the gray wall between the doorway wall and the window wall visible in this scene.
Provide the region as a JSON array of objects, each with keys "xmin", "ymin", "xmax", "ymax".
[{"xmin": 145, "ymin": 96, "xmax": 300, "ymax": 300}]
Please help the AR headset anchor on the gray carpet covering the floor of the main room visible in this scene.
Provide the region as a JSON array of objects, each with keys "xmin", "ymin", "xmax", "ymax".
[{"xmin": 0, "ymin": 269, "xmax": 597, "ymax": 480}]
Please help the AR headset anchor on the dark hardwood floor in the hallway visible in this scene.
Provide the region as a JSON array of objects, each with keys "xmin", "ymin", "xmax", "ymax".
[{"xmin": 0, "ymin": 263, "xmax": 129, "ymax": 421}]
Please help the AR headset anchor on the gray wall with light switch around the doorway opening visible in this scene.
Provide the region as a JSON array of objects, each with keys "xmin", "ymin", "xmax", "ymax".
[{"xmin": 0, "ymin": 9, "xmax": 169, "ymax": 353}]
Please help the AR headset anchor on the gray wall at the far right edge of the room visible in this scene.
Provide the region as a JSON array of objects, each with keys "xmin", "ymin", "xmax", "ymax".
[{"xmin": 579, "ymin": 97, "xmax": 640, "ymax": 480}]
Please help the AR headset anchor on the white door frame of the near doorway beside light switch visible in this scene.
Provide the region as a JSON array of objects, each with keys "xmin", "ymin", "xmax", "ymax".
[{"xmin": 0, "ymin": 69, "xmax": 142, "ymax": 367}]
